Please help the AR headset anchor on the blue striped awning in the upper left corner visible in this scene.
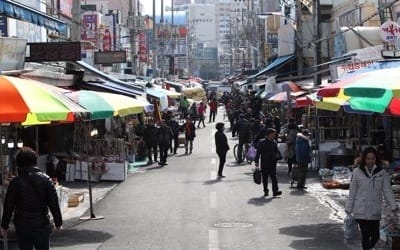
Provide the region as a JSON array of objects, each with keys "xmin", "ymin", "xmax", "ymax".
[{"xmin": 0, "ymin": 0, "xmax": 67, "ymax": 34}]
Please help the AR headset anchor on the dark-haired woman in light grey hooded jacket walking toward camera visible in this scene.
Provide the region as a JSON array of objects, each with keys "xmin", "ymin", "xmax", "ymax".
[{"xmin": 345, "ymin": 147, "xmax": 397, "ymax": 250}]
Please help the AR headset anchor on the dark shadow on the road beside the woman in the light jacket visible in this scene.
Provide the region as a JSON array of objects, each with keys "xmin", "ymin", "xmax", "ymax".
[{"xmin": 279, "ymin": 223, "xmax": 347, "ymax": 250}]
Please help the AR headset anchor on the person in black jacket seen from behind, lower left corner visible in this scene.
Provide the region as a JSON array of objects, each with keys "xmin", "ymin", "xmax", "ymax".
[{"xmin": 1, "ymin": 147, "xmax": 63, "ymax": 250}]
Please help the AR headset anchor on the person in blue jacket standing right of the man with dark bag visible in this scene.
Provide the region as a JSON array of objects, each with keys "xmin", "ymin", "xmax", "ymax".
[{"xmin": 296, "ymin": 129, "xmax": 311, "ymax": 188}]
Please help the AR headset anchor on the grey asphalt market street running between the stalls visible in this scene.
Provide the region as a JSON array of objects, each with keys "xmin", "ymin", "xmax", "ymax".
[{"xmin": 10, "ymin": 110, "xmax": 346, "ymax": 250}]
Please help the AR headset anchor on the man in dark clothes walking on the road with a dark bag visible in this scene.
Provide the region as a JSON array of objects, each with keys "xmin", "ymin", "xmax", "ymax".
[{"xmin": 255, "ymin": 128, "xmax": 282, "ymax": 196}]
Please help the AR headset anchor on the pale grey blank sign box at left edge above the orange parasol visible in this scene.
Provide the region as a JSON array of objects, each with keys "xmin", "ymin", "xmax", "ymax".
[{"xmin": 0, "ymin": 37, "xmax": 26, "ymax": 71}]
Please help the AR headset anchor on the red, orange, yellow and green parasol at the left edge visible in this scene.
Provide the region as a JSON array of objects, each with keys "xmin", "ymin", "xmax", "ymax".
[{"xmin": 0, "ymin": 76, "xmax": 86, "ymax": 125}]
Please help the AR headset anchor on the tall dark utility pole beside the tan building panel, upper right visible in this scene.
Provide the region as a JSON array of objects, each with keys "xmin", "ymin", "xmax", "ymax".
[{"xmin": 313, "ymin": 0, "xmax": 322, "ymax": 86}]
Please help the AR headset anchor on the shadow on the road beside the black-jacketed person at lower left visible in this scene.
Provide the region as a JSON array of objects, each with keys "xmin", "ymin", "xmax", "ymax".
[{"xmin": 51, "ymin": 229, "xmax": 113, "ymax": 247}]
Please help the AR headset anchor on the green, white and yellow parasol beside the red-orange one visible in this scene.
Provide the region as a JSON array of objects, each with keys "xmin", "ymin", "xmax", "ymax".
[{"xmin": 65, "ymin": 90, "xmax": 152, "ymax": 120}]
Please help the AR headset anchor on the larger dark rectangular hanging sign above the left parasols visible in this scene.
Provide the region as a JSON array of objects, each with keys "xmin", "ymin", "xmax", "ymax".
[{"xmin": 25, "ymin": 42, "xmax": 81, "ymax": 62}]
